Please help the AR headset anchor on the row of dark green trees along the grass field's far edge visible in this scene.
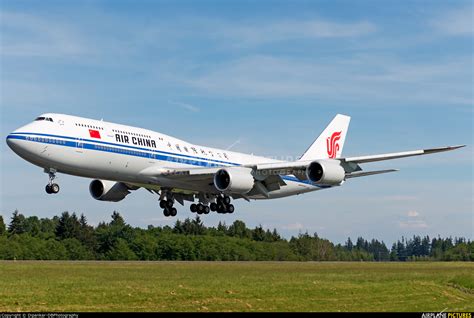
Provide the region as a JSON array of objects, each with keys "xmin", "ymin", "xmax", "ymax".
[{"xmin": 0, "ymin": 211, "xmax": 474, "ymax": 261}]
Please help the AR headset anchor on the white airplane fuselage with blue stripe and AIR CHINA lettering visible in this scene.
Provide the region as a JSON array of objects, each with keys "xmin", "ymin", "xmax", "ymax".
[{"xmin": 7, "ymin": 114, "xmax": 320, "ymax": 199}]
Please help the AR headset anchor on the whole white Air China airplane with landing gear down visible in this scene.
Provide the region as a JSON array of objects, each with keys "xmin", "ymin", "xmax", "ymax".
[{"xmin": 7, "ymin": 114, "xmax": 464, "ymax": 216}]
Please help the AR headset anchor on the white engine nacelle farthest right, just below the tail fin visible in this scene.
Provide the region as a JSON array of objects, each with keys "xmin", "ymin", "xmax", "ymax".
[{"xmin": 306, "ymin": 160, "xmax": 346, "ymax": 186}]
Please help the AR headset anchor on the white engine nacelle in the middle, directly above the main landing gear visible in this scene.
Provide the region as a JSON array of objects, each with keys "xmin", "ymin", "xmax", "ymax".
[{"xmin": 214, "ymin": 167, "xmax": 255, "ymax": 194}]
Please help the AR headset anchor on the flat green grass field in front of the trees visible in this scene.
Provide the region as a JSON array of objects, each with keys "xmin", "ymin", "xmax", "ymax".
[{"xmin": 0, "ymin": 261, "xmax": 474, "ymax": 311}]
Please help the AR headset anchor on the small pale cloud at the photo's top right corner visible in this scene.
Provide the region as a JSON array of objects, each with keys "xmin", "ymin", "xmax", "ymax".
[{"xmin": 431, "ymin": 4, "xmax": 474, "ymax": 36}]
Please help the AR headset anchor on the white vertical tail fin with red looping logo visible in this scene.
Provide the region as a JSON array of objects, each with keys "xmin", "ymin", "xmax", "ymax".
[{"xmin": 299, "ymin": 114, "xmax": 351, "ymax": 160}]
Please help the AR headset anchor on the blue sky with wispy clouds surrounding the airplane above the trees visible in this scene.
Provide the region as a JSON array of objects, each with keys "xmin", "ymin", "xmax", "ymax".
[{"xmin": 0, "ymin": 1, "xmax": 474, "ymax": 243}]
